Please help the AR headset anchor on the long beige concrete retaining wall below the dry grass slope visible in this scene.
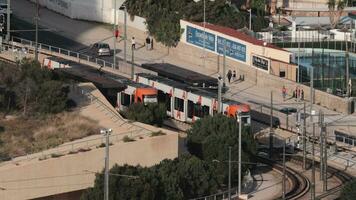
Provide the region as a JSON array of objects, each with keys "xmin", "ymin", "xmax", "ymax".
[{"xmin": 0, "ymin": 134, "xmax": 179, "ymax": 200}]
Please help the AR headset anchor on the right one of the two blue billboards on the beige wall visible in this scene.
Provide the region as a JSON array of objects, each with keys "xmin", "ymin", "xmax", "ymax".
[{"xmin": 217, "ymin": 36, "xmax": 246, "ymax": 62}]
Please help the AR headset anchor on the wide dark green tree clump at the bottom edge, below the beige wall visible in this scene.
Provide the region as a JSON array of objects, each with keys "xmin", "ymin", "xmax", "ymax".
[{"xmin": 81, "ymin": 154, "xmax": 217, "ymax": 200}]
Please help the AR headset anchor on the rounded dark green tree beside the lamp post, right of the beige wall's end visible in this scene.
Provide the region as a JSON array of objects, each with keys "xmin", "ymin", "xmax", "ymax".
[{"xmin": 187, "ymin": 115, "xmax": 256, "ymax": 185}]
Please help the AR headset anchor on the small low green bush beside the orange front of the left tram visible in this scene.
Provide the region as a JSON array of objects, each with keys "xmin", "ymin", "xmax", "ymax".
[{"xmin": 124, "ymin": 103, "xmax": 167, "ymax": 126}]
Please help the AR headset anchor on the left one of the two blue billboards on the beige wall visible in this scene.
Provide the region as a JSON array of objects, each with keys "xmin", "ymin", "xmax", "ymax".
[{"xmin": 187, "ymin": 26, "xmax": 215, "ymax": 51}]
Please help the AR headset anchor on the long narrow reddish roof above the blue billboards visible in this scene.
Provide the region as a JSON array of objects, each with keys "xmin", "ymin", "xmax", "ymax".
[{"xmin": 189, "ymin": 22, "xmax": 288, "ymax": 52}]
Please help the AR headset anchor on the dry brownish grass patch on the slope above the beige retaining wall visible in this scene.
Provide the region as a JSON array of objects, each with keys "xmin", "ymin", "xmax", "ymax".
[{"xmin": 0, "ymin": 112, "xmax": 99, "ymax": 157}]
